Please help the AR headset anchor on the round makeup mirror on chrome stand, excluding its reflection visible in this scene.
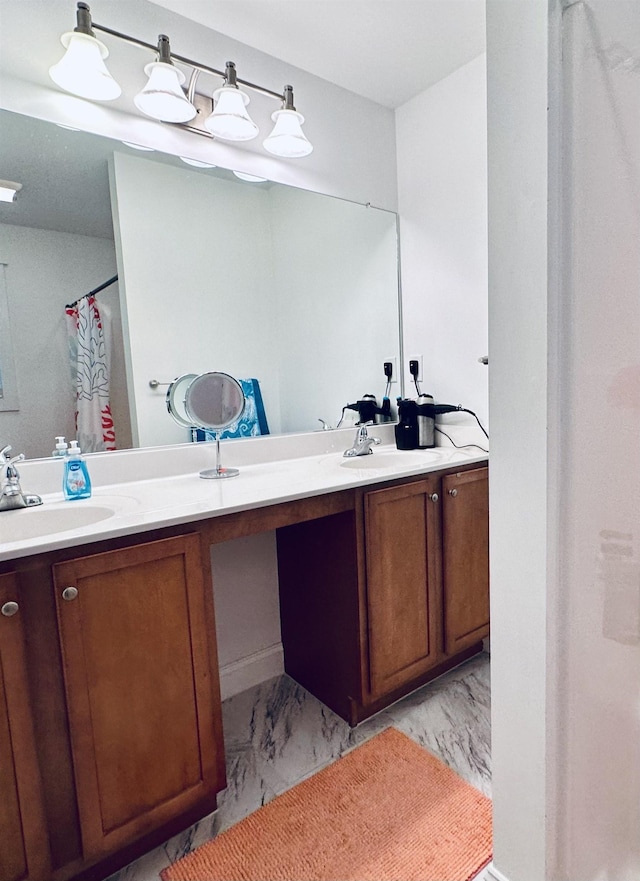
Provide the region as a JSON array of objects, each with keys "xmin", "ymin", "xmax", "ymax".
[{"xmin": 184, "ymin": 371, "xmax": 245, "ymax": 478}]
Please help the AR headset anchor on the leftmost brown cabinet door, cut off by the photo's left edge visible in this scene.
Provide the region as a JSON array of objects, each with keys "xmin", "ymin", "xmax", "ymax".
[{"xmin": 0, "ymin": 574, "xmax": 50, "ymax": 881}]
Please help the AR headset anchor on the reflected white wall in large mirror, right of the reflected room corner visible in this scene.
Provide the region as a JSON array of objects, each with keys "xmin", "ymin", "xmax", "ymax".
[{"xmin": 272, "ymin": 187, "xmax": 400, "ymax": 431}]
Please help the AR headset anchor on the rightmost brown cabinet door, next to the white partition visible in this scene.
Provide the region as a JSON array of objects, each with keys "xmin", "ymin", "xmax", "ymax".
[{"xmin": 442, "ymin": 467, "xmax": 489, "ymax": 654}]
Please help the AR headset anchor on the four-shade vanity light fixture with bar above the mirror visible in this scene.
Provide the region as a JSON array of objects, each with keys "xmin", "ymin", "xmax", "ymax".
[{"xmin": 49, "ymin": 2, "xmax": 313, "ymax": 159}]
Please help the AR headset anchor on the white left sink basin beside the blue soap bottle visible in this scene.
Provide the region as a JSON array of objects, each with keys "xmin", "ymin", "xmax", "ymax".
[{"xmin": 0, "ymin": 499, "xmax": 133, "ymax": 544}]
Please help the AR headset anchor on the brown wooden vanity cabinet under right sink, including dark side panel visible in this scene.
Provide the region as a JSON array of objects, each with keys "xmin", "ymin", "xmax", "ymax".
[{"xmin": 278, "ymin": 466, "xmax": 489, "ymax": 725}]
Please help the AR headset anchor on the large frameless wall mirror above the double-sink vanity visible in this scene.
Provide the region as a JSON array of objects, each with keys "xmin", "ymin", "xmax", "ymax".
[{"xmin": 0, "ymin": 111, "xmax": 401, "ymax": 457}]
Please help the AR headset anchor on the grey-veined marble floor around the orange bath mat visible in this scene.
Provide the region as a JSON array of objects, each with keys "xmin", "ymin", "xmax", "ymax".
[{"xmin": 108, "ymin": 654, "xmax": 491, "ymax": 881}]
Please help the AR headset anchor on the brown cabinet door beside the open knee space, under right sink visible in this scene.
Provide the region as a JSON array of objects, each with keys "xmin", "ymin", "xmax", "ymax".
[{"xmin": 365, "ymin": 478, "xmax": 440, "ymax": 699}]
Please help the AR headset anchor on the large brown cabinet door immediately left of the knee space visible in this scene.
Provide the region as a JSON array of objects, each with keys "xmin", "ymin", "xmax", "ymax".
[{"xmin": 54, "ymin": 535, "xmax": 224, "ymax": 859}]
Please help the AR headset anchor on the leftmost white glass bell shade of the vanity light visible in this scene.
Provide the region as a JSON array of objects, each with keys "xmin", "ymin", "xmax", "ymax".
[{"xmin": 49, "ymin": 31, "xmax": 122, "ymax": 101}]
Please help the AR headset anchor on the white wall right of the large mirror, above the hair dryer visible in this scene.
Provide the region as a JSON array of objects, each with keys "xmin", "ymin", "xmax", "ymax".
[{"xmin": 396, "ymin": 55, "xmax": 488, "ymax": 436}]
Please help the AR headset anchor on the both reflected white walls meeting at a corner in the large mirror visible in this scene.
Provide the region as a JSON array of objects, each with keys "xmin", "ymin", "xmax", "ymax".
[{"xmin": 112, "ymin": 154, "xmax": 399, "ymax": 446}]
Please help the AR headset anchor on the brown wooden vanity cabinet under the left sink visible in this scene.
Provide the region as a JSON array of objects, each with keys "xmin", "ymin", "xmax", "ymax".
[{"xmin": 0, "ymin": 530, "xmax": 225, "ymax": 881}]
